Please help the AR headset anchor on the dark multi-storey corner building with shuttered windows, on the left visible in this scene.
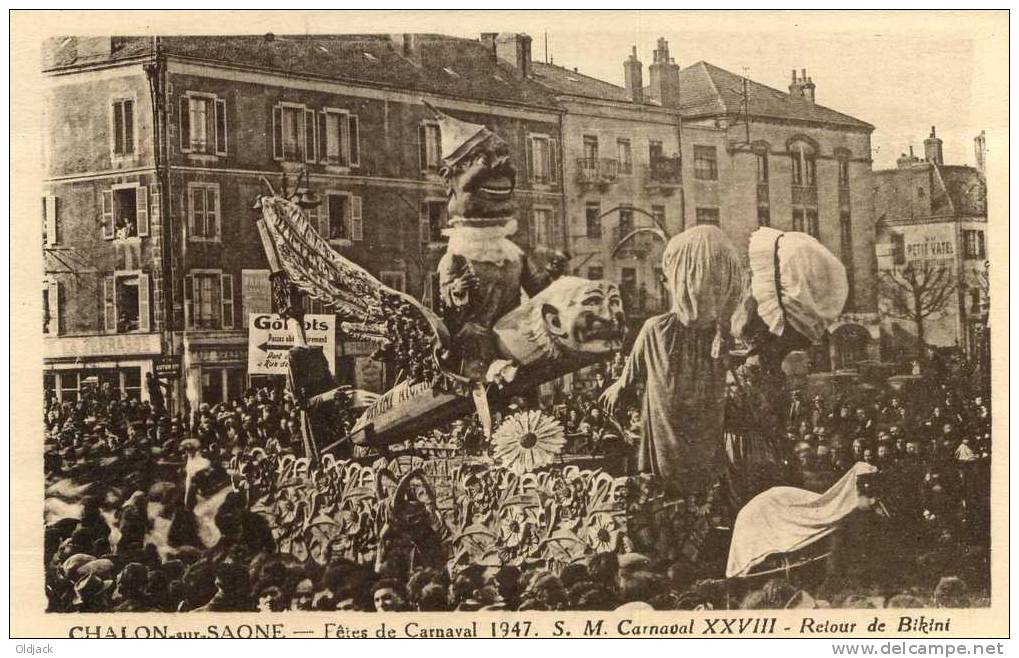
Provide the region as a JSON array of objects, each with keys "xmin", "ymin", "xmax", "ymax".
[{"xmin": 43, "ymin": 35, "xmax": 565, "ymax": 405}]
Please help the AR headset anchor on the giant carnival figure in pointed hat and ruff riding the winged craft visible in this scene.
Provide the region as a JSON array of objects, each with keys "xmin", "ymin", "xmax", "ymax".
[{"xmin": 428, "ymin": 105, "xmax": 568, "ymax": 382}]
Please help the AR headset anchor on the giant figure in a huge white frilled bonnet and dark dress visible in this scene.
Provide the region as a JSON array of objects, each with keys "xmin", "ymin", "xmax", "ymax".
[{"xmin": 723, "ymin": 226, "xmax": 849, "ymax": 512}]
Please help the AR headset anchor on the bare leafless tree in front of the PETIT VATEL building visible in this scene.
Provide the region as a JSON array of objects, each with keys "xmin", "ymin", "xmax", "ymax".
[{"xmin": 879, "ymin": 261, "xmax": 957, "ymax": 363}]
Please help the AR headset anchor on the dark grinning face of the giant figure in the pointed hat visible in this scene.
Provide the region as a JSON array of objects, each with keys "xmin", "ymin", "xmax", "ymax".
[{"xmin": 439, "ymin": 134, "xmax": 517, "ymax": 220}]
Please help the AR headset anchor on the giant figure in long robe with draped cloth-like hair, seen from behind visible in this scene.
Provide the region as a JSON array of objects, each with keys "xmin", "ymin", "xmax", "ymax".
[{"xmin": 600, "ymin": 225, "xmax": 745, "ymax": 495}]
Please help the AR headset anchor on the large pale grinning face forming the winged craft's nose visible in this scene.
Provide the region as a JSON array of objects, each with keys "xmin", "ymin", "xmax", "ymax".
[{"xmin": 528, "ymin": 276, "xmax": 625, "ymax": 357}]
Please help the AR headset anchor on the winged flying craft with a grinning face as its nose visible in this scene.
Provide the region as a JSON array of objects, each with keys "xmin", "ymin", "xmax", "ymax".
[{"xmin": 256, "ymin": 188, "xmax": 624, "ymax": 446}]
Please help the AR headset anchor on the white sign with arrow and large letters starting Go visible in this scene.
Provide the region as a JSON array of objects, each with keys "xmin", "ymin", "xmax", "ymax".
[{"xmin": 248, "ymin": 313, "xmax": 336, "ymax": 376}]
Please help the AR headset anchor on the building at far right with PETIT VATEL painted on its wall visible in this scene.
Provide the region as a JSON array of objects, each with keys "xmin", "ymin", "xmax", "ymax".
[{"xmin": 873, "ymin": 126, "xmax": 988, "ymax": 361}]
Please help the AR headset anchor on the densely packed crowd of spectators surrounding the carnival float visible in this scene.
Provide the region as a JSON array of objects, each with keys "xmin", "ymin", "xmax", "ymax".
[{"xmin": 45, "ymin": 352, "xmax": 990, "ymax": 611}]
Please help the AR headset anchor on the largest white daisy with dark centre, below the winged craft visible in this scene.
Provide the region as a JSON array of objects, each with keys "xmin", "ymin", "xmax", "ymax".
[{"xmin": 492, "ymin": 410, "xmax": 567, "ymax": 474}]
